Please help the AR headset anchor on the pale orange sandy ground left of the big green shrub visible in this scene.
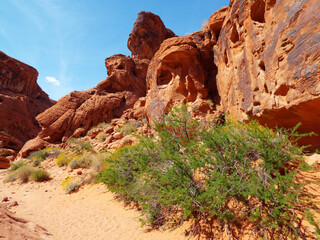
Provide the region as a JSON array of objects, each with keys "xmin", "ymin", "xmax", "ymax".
[{"xmin": 0, "ymin": 164, "xmax": 185, "ymax": 240}]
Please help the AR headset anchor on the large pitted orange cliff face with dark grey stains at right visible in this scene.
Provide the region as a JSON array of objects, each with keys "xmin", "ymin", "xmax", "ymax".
[{"xmin": 214, "ymin": 0, "xmax": 320, "ymax": 148}]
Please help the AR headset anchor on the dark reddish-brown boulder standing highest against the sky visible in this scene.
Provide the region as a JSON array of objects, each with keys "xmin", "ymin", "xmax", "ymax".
[{"xmin": 128, "ymin": 11, "xmax": 176, "ymax": 60}]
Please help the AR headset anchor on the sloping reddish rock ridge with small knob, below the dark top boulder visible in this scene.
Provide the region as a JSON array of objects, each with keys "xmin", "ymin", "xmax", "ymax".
[{"xmin": 33, "ymin": 54, "xmax": 146, "ymax": 143}]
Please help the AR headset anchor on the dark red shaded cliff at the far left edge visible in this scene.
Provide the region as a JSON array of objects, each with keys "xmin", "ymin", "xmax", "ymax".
[{"xmin": 0, "ymin": 51, "xmax": 54, "ymax": 168}]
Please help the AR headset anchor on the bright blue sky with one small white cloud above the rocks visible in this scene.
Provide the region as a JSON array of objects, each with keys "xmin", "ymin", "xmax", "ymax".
[{"xmin": 0, "ymin": 0, "xmax": 229, "ymax": 100}]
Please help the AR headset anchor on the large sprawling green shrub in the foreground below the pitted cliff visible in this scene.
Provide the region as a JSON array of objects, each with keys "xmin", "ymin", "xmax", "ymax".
[{"xmin": 99, "ymin": 105, "xmax": 319, "ymax": 239}]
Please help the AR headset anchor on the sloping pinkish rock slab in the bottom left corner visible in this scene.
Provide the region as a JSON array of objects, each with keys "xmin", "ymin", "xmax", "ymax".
[{"xmin": 0, "ymin": 205, "xmax": 53, "ymax": 240}]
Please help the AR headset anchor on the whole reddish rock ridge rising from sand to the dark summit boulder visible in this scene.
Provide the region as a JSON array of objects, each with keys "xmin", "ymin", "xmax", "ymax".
[{"xmin": 19, "ymin": 12, "xmax": 175, "ymax": 157}]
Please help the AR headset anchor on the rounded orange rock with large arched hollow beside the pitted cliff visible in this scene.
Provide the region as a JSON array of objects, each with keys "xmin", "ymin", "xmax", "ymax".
[{"xmin": 146, "ymin": 29, "xmax": 219, "ymax": 121}]
